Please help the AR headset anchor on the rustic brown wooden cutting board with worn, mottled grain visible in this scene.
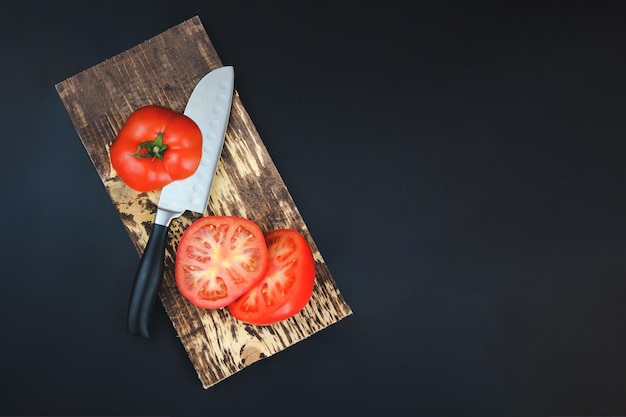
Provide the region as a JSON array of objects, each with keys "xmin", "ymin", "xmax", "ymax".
[{"xmin": 56, "ymin": 16, "xmax": 352, "ymax": 388}]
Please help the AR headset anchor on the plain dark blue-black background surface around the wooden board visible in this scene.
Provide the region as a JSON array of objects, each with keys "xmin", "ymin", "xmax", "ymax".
[{"xmin": 0, "ymin": 0, "xmax": 626, "ymax": 416}]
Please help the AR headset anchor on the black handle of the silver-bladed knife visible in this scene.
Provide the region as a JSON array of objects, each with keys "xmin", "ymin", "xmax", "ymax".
[{"xmin": 128, "ymin": 223, "xmax": 167, "ymax": 338}]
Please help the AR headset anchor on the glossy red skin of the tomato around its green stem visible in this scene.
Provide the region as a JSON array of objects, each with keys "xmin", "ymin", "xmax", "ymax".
[{"xmin": 110, "ymin": 105, "xmax": 202, "ymax": 192}]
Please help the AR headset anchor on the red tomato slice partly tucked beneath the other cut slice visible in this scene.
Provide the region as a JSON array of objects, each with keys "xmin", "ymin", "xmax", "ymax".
[{"xmin": 228, "ymin": 229, "xmax": 315, "ymax": 325}]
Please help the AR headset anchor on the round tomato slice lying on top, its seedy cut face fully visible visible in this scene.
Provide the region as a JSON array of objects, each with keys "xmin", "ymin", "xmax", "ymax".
[{"xmin": 175, "ymin": 216, "xmax": 268, "ymax": 309}]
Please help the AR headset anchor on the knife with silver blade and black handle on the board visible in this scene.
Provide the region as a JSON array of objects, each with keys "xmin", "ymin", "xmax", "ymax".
[{"xmin": 128, "ymin": 67, "xmax": 235, "ymax": 338}]
